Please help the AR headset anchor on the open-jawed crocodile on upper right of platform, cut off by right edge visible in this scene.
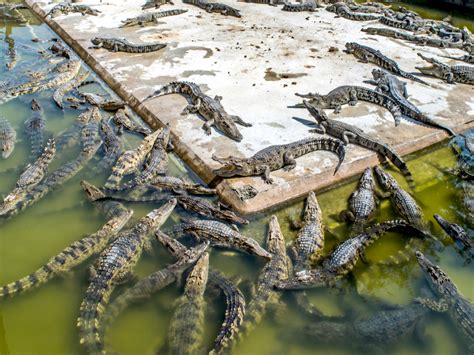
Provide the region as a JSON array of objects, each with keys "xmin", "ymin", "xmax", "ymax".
[{"xmin": 416, "ymin": 53, "xmax": 474, "ymax": 85}]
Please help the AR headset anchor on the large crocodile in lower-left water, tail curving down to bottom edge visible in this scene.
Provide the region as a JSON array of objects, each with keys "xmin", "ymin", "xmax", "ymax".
[{"xmin": 77, "ymin": 200, "xmax": 176, "ymax": 354}]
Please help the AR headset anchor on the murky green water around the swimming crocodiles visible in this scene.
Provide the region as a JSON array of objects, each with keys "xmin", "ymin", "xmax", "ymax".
[{"xmin": 0, "ymin": 2, "xmax": 474, "ymax": 355}]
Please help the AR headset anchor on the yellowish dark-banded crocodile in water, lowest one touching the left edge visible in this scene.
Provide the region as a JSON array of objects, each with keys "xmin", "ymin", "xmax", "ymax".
[{"xmin": 0, "ymin": 210, "xmax": 133, "ymax": 297}]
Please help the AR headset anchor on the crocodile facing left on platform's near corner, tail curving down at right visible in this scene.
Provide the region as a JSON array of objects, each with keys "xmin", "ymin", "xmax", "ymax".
[{"xmin": 212, "ymin": 138, "xmax": 346, "ymax": 184}]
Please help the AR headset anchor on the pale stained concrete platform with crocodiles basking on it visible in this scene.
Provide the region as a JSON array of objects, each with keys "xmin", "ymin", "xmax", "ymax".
[{"xmin": 27, "ymin": 0, "xmax": 474, "ymax": 214}]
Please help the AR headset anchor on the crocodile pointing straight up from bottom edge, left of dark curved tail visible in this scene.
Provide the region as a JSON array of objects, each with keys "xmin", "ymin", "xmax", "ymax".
[{"xmin": 167, "ymin": 252, "xmax": 209, "ymax": 355}]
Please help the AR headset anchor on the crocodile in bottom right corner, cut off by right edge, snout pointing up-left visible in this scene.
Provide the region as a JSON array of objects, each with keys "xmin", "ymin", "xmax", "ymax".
[{"xmin": 416, "ymin": 251, "xmax": 474, "ymax": 352}]
